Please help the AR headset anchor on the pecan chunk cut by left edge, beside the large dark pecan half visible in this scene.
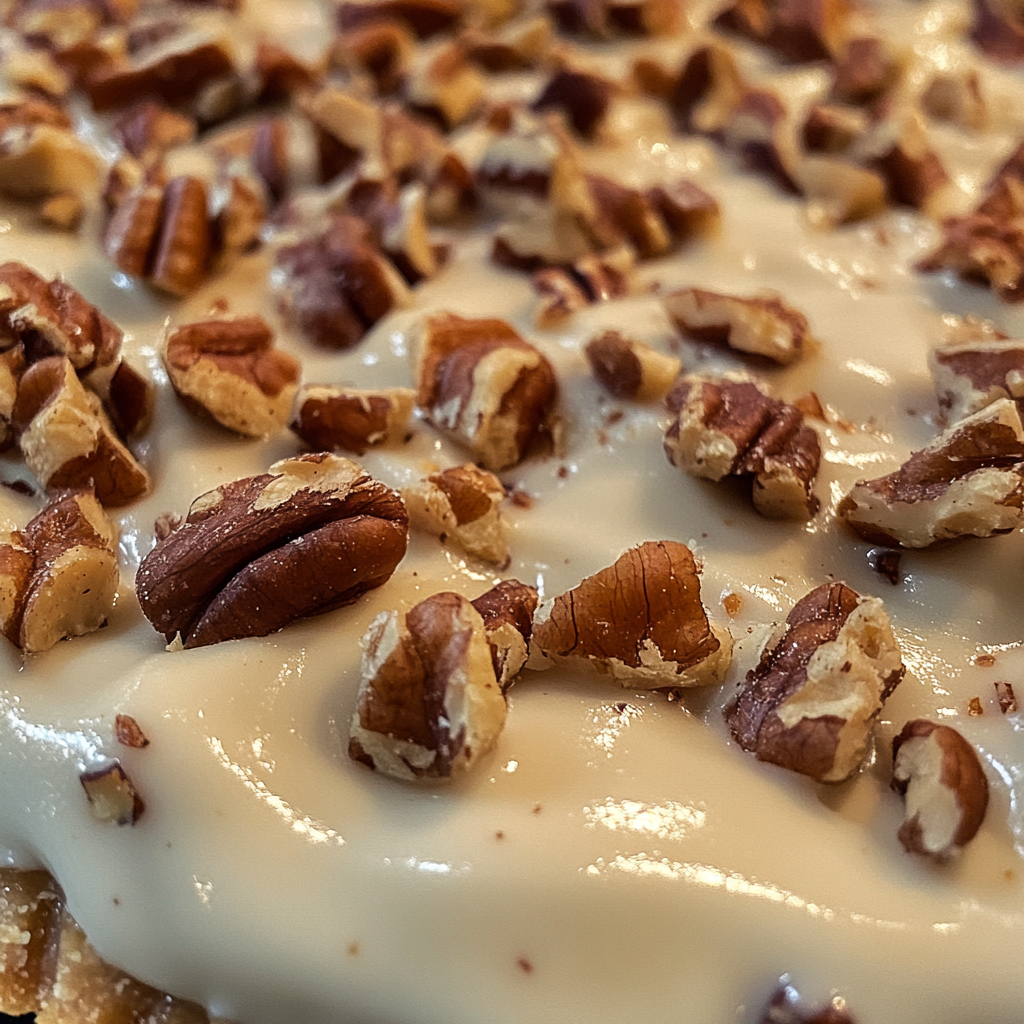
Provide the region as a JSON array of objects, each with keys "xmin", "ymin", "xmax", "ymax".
[{"xmin": 0, "ymin": 490, "xmax": 120, "ymax": 654}]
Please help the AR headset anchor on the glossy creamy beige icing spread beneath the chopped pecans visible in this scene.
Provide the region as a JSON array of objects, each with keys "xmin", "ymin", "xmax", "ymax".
[{"xmin": 0, "ymin": 5, "xmax": 1024, "ymax": 1024}]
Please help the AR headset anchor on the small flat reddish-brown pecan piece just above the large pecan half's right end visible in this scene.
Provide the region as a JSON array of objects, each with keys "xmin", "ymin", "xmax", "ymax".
[{"xmin": 291, "ymin": 384, "xmax": 416, "ymax": 455}]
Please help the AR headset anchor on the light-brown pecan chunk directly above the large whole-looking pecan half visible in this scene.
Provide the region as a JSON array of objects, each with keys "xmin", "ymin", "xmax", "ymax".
[{"xmin": 164, "ymin": 316, "xmax": 299, "ymax": 437}]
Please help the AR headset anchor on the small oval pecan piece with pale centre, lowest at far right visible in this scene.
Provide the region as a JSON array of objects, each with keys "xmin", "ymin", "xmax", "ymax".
[{"xmin": 892, "ymin": 719, "xmax": 988, "ymax": 858}]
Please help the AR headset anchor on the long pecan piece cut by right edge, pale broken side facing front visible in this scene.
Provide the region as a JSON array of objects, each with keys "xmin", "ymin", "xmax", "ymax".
[{"xmin": 837, "ymin": 398, "xmax": 1024, "ymax": 548}]
